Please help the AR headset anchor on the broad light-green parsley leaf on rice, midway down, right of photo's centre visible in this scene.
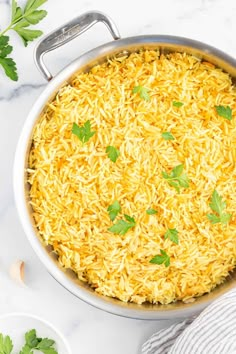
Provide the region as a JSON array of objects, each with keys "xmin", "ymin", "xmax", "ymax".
[{"xmin": 162, "ymin": 164, "xmax": 189, "ymax": 193}]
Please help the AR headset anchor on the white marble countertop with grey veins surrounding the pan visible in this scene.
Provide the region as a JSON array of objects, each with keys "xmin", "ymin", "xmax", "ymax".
[{"xmin": 0, "ymin": 0, "xmax": 236, "ymax": 354}]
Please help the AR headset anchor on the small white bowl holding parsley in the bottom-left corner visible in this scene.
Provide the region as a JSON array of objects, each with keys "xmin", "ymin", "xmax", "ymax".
[{"xmin": 0, "ymin": 312, "xmax": 71, "ymax": 354}]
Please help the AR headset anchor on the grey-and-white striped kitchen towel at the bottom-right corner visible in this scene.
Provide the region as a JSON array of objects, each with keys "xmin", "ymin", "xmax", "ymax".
[{"xmin": 142, "ymin": 288, "xmax": 236, "ymax": 354}]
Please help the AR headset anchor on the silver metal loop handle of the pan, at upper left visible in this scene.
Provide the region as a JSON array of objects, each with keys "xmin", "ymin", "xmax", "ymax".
[{"xmin": 34, "ymin": 11, "xmax": 120, "ymax": 81}]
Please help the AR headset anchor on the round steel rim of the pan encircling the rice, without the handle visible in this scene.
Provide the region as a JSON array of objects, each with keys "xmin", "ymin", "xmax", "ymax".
[{"xmin": 13, "ymin": 35, "xmax": 236, "ymax": 320}]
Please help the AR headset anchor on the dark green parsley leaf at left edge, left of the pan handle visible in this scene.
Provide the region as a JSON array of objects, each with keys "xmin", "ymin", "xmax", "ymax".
[{"xmin": 0, "ymin": 36, "xmax": 18, "ymax": 81}]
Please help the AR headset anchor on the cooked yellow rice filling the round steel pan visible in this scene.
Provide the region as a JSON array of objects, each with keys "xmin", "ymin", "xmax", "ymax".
[{"xmin": 28, "ymin": 50, "xmax": 236, "ymax": 304}]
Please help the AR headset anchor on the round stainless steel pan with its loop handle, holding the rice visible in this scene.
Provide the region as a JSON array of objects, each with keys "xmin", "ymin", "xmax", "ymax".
[{"xmin": 14, "ymin": 12, "xmax": 236, "ymax": 320}]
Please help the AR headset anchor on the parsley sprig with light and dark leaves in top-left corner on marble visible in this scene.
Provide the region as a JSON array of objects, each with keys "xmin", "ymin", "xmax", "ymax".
[{"xmin": 0, "ymin": 0, "xmax": 47, "ymax": 81}]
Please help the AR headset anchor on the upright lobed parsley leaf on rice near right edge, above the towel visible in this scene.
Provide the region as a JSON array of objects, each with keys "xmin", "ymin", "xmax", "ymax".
[{"xmin": 207, "ymin": 190, "xmax": 232, "ymax": 224}]
